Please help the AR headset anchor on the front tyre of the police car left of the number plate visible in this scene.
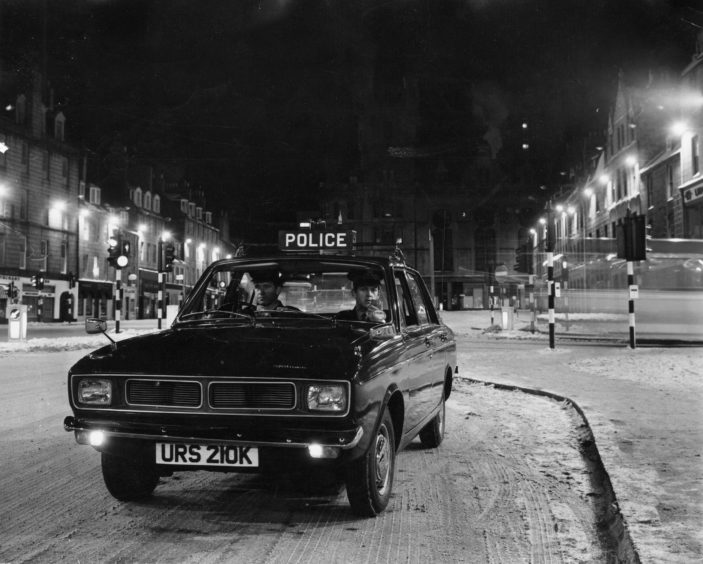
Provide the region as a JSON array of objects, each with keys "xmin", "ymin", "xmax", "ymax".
[{"xmin": 102, "ymin": 452, "xmax": 159, "ymax": 501}]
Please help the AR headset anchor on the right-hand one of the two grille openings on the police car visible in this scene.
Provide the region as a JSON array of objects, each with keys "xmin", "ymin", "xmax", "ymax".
[{"xmin": 209, "ymin": 382, "xmax": 295, "ymax": 409}]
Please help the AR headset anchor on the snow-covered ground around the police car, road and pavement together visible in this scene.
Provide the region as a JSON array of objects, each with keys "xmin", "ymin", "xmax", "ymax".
[{"xmin": 0, "ymin": 311, "xmax": 703, "ymax": 562}]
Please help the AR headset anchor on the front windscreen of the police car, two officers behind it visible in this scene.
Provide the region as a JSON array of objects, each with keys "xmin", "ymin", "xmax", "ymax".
[{"xmin": 179, "ymin": 261, "xmax": 389, "ymax": 319}]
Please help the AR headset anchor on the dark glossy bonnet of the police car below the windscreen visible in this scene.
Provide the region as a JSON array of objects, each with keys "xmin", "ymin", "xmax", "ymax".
[{"xmin": 71, "ymin": 326, "xmax": 373, "ymax": 378}]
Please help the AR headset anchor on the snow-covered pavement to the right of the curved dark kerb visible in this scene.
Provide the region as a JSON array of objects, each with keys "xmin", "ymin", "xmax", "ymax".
[{"xmin": 442, "ymin": 311, "xmax": 703, "ymax": 563}]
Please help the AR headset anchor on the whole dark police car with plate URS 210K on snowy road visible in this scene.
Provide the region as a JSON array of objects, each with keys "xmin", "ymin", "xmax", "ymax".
[{"xmin": 64, "ymin": 254, "xmax": 456, "ymax": 516}]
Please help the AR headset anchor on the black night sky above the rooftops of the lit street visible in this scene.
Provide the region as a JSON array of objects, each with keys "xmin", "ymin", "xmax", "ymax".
[{"xmin": 0, "ymin": 0, "xmax": 703, "ymax": 234}]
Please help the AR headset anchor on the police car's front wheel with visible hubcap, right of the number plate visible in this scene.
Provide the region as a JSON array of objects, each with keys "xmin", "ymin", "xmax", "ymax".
[{"xmin": 345, "ymin": 411, "xmax": 395, "ymax": 517}]
